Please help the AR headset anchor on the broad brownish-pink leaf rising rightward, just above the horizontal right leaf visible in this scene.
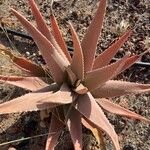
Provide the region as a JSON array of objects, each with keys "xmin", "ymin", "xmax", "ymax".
[{"xmin": 85, "ymin": 55, "xmax": 128, "ymax": 91}]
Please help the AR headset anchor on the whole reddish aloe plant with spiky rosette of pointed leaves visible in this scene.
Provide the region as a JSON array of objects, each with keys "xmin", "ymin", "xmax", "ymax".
[{"xmin": 0, "ymin": 0, "xmax": 150, "ymax": 150}]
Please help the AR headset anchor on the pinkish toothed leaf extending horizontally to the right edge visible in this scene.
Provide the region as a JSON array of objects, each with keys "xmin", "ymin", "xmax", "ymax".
[{"xmin": 92, "ymin": 80, "xmax": 150, "ymax": 98}]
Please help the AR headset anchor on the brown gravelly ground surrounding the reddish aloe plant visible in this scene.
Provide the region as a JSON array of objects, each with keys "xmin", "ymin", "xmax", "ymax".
[{"xmin": 0, "ymin": 0, "xmax": 150, "ymax": 150}]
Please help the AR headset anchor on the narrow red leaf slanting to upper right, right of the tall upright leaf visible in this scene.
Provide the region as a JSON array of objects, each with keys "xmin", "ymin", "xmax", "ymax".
[{"xmin": 93, "ymin": 29, "xmax": 132, "ymax": 69}]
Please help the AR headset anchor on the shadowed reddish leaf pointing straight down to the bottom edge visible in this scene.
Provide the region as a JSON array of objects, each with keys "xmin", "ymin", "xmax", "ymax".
[{"xmin": 67, "ymin": 108, "xmax": 82, "ymax": 150}]
